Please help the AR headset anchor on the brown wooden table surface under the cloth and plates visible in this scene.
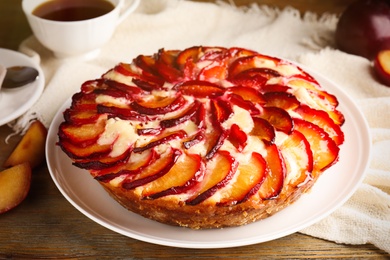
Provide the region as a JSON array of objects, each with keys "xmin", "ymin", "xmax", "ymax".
[{"xmin": 0, "ymin": 0, "xmax": 389, "ymax": 259}]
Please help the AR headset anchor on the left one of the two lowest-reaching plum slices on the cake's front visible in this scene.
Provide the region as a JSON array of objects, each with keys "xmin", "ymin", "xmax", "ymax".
[{"xmin": 186, "ymin": 151, "xmax": 238, "ymax": 205}]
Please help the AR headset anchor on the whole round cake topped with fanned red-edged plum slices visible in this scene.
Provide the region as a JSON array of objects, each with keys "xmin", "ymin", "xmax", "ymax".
[{"xmin": 58, "ymin": 46, "xmax": 344, "ymax": 229}]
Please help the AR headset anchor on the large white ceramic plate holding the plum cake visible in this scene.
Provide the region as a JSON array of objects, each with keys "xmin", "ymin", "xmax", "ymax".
[{"xmin": 46, "ymin": 66, "xmax": 371, "ymax": 248}]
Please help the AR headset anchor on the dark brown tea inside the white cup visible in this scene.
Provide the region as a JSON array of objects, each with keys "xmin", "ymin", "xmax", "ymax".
[{"xmin": 32, "ymin": 0, "xmax": 115, "ymax": 22}]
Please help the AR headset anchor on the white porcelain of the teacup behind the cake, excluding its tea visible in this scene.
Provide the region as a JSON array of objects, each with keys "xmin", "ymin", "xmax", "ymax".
[{"xmin": 22, "ymin": 0, "xmax": 140, "ymax": 58}]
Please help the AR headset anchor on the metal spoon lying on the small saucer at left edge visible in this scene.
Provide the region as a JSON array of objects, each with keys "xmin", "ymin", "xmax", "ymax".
[{"xmin": 1, "ymin": 66, "xmax": 39, "ymax": 88}]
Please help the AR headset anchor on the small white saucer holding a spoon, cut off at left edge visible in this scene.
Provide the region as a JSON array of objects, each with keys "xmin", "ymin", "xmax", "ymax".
[{"xmin": 0, "ymin": 48, "xmax": 45, "ymax": 126}]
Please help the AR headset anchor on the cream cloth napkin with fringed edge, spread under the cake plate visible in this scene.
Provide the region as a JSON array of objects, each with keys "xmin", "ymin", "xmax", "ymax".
[{"xmin": 11, "ymin": 0, "xmax": 390, "ymax": 253}]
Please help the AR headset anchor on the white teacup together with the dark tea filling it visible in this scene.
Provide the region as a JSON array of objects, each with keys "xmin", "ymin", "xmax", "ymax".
[{"xmin": 22, "ymin": 0, "xmax": 140, "ymax": 58}]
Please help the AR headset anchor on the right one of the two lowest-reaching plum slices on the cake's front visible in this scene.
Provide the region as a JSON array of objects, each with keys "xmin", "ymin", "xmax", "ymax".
[{"xmin": 218, "ymin": 152, "xmax": 267, "ymax": 206}]
